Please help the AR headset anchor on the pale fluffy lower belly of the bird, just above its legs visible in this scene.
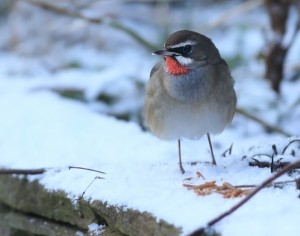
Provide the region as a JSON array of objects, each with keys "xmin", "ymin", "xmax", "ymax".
[{"xmin": 148, "ymin": 98, "xmax": 231, "ymax": 140}]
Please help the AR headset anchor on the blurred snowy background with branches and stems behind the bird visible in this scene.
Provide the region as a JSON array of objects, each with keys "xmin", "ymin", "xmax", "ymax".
[{"xmin": 0, "ymin": 0, "xmax": 300, "ymax": 137}]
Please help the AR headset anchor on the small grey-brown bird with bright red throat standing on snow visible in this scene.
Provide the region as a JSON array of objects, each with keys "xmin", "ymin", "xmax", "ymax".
[{"xmin": 144, "ymin": 30, "xmax": 237, "ymax": 174}]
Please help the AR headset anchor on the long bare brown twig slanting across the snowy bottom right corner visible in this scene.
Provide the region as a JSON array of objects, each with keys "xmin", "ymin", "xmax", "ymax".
[{"xmin": 189, "ymin": 160, "xmax": 300, "ymax": 236}]
